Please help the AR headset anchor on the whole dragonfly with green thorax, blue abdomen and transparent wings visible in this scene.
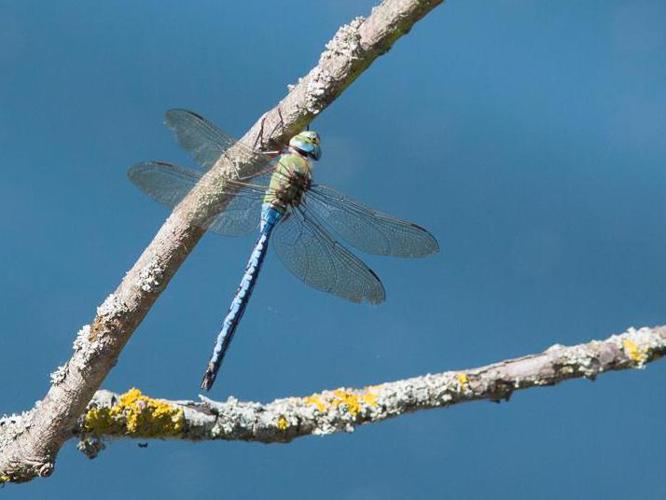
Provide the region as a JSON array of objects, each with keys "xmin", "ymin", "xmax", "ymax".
[{"xmin": 128, "ymin": 109, "xmax": 439, "ymax": 390}]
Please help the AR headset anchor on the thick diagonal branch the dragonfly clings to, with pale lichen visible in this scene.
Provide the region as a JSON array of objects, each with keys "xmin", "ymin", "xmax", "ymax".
[{"xmin": 0, "ymin": 0, "xmax": 443, "ymax": 482}]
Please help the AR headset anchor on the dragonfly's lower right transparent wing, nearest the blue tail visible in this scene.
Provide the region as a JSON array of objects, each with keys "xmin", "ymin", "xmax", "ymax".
[{"xmin": 272, "ymin": 207, "xmax": 385, "ymax": 304}]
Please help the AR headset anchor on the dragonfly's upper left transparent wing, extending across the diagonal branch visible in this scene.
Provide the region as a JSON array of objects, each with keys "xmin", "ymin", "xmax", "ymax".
[{"xmin": 166, "ymin": 109, "xmax": 274, "ymax": 174}]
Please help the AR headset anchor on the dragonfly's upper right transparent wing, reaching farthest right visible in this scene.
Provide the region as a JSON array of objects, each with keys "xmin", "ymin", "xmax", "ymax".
[{"xmin": 303, "ymin": 184, "xmax": 439, "ymax": 257}]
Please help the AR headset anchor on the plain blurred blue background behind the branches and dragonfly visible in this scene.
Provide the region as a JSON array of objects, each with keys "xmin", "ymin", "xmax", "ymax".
[{"xmin": 0, "ymin": 0, "xmax": 666, "ymax": 500}]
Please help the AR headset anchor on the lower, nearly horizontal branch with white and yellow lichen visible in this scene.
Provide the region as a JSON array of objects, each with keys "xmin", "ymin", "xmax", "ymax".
[{"xmin": 65, "ymin": 326, "xmax": 666, "ymax": 450}]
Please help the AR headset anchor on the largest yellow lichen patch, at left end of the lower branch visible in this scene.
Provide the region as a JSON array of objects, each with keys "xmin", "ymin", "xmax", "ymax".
[{"xmin": 84, "ymin": 388, "xmax": 185, "ymax": 437}]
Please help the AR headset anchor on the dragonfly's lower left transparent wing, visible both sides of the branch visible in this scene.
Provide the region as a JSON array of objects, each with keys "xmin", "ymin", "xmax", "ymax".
[{"xmin": 127, "ymin": 161, "xmax": 270, "ymax": 236}]
